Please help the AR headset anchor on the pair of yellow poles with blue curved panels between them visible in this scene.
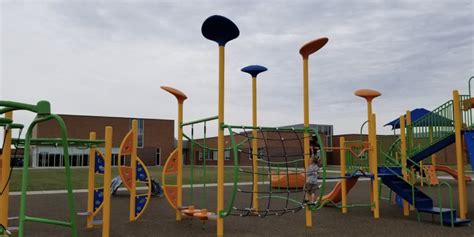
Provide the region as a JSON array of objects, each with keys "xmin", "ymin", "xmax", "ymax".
[{"xmin": 78, "ymin": 127, "xmax": 112, "ymax": 237}]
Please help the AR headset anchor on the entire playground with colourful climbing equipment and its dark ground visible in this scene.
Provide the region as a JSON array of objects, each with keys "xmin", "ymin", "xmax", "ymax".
[{"xmin": 0, "ymin": 12, "xmax": 474, "ymax": 237}]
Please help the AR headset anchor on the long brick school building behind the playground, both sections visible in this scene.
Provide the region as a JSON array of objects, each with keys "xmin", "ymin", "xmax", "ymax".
[{"xmin": 19, "ymin": 114, "xmax": 462, "ymax": 167}]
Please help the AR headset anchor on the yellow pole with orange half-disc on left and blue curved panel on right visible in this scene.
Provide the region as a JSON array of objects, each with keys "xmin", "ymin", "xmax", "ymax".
[{"xmin": 116, "ymin": 119, "xmax": 152, "ymax": 221}]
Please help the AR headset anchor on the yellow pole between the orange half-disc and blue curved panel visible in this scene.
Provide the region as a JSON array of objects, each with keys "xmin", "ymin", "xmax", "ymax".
[{"xmin": 130, "ymin": 119, "xmax": 138, "ymax": 221}]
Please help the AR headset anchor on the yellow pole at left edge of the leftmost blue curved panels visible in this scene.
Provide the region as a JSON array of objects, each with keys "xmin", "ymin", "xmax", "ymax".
[{"xmin": 86, "ymin": 132, "xmax": 96, "ymax": 229}]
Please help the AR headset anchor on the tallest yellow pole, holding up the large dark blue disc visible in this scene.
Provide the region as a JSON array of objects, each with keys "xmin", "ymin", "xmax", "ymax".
[{"xmin": 217, "ymin": 46, "xmax": 225, "ymax": 236}]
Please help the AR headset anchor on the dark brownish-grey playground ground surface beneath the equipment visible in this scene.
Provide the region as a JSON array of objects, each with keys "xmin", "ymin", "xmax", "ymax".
[{"xmin": 10, "ymin": 181, "xmax": 474, "ymax": 237}]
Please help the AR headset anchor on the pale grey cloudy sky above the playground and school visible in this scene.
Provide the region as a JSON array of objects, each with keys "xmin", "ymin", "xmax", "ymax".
[{"xmin": 0, "ymin": 0, "xmax": 474, "ymax": 138}]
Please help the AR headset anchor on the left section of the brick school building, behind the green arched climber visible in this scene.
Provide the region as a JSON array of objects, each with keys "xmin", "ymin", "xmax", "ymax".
[{"xmin": 31, "ymin": 114, "xmax": 174, "ymax": 167}]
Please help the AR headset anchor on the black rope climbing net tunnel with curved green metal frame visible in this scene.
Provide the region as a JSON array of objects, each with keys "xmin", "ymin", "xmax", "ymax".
[{"xmin": 183, "ymin": 117, "xmax": 326, "ymax": 218}]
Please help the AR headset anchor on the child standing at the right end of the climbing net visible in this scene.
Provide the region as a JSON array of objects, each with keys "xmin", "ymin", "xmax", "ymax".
[{"xmin": 305, "ymin": 141, "xmax": 320, "ymax": 205}]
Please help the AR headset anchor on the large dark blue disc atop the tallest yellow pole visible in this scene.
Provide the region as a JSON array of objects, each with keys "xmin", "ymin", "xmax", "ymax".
[{"xmin": 201, "ymin": 15, "xmax": 240, "ymax": 46}]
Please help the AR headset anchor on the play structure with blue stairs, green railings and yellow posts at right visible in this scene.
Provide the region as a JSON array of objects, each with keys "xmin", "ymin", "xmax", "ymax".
[{"xmin": 378, "ymin": 83, "xmax": 473, "ymax": 226}]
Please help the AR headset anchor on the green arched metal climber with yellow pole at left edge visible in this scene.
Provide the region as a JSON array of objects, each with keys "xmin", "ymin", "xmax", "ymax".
[{"xmin": 0, "ymin": 101, "xmax": 111, "ymax": 237}]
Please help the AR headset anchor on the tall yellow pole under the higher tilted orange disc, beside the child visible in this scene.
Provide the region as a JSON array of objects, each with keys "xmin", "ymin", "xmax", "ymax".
[{"xmin": 303, "ymin": 58, "xmax": 313, "ymax": 227}]
